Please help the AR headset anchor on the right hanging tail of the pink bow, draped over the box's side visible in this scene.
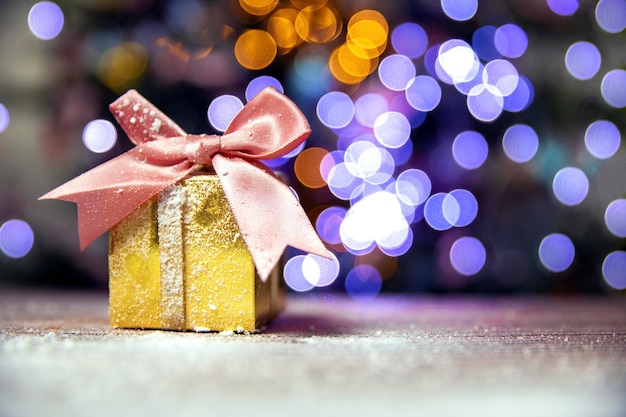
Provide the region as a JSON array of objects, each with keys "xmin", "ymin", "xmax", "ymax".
[{"xmin": 213, "ymin": 155, "xmax": 332, "ymax": 281}]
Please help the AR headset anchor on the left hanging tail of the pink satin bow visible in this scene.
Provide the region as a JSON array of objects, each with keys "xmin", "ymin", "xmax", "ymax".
[{"xmin": 39, "ymin": 147, "xmax": 193, "ymax": 250}]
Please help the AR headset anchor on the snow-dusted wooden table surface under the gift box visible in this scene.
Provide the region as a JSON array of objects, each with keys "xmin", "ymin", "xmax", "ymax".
[{"xmin": 0, "ymin": 289, "xmax": 626, "ymax": 417}]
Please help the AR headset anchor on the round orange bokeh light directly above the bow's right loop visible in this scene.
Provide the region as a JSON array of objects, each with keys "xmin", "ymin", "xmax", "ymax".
[{"xmin": 235, "ymin": 29, "xmax": 277, "ymax": 70}]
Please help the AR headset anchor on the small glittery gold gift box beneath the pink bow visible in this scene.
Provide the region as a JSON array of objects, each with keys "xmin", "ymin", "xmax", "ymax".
[{"xmin": 109, "ymin": 175, "xmax": 285, "ymax": 331}]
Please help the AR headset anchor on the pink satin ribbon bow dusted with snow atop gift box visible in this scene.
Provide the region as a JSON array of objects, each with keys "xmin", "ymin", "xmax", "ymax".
[{"xmin": 40, "ymin": 88, "xmax": 330, "ymax": 280}]
